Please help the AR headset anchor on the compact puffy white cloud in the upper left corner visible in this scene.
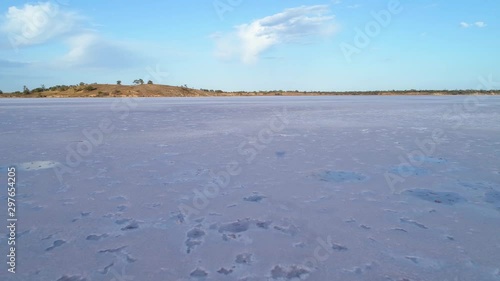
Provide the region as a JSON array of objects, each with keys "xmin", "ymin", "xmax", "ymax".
[{"xmin": 0, "ymin": 2, "xmax": 82, "ymax": 47}]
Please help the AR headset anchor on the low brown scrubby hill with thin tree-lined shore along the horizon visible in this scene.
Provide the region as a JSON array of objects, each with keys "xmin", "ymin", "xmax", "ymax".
[{"xmin": 0, "ymin": 84, "xmax": 500, "ymax": 98}]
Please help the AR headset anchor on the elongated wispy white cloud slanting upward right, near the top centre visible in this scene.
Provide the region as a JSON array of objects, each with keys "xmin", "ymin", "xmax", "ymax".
[{"xmin": 212, "ymin": 5, "xmax": 336, "ymax": 63}]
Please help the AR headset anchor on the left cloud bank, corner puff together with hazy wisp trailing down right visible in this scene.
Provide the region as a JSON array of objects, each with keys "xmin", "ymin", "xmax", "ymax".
[{"xmin": 0, "ymin": 2, "xmax": 146, "ymax": 68}]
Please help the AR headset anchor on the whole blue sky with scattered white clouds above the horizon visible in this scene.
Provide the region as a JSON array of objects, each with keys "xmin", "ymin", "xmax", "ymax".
[{"xmin": 0, "ymin": 0, "xmax": 500, "ymax": 92}]
